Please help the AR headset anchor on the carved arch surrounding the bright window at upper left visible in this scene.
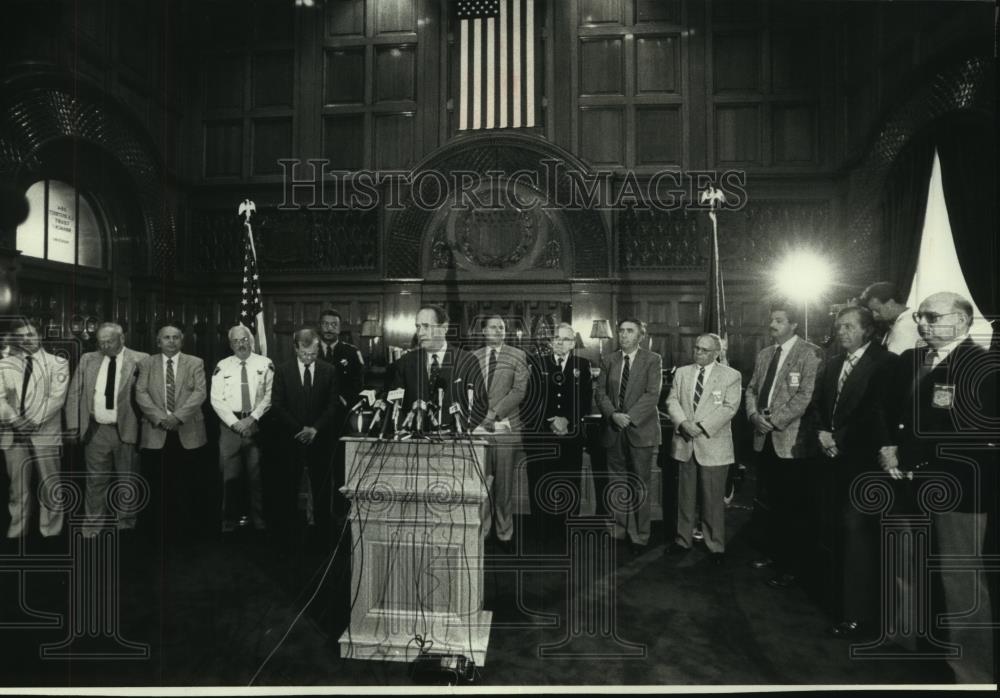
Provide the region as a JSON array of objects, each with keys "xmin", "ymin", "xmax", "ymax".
[{"xmin": 0, "ymin": 71, "xmax": 176, "ymax": 274}]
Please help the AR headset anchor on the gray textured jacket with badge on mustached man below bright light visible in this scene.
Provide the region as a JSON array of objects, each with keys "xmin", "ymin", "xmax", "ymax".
[{"xmin": 745, "ymin": 337, "xmax": 820, "ymax": 458}]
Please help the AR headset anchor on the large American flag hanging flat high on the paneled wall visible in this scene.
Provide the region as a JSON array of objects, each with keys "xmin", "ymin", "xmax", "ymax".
[{"xmin": 455, "ymin": 0, "xmax": 538, "ymax": 131}]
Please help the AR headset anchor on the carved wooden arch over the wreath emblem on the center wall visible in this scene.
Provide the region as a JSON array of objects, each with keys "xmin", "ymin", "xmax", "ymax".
[{"xmin": 385, "ymin": 133, "xmax": 612, "ymax": 279}]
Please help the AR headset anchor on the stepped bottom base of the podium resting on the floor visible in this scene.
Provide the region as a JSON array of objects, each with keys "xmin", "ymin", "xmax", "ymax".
[{"xmin": 339, "ymin": 611, "xmax": 493, "ymax": 667}]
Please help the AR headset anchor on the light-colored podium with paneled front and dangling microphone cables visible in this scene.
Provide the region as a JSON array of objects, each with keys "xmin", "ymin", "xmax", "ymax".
[{"xmin": 340, "ymin": 437, "xmax": 493, "ymax": 666}]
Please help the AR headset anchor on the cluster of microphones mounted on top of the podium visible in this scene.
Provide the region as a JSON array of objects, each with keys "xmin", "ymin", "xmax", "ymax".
[{"xmin": 349, "ymin": 379, "xmax": 475, "ymax": 440}]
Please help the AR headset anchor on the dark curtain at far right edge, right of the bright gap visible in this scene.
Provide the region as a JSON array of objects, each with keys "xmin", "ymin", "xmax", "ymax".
[{"xmin": 935, "ymin": 112, "xmax": 1000, "ymax": 317}]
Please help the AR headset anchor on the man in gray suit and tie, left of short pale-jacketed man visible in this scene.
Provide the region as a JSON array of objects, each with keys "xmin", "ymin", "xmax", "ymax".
[{"xmin": 597, "ymin": 318, "xmax": 663, "ymax": 550}]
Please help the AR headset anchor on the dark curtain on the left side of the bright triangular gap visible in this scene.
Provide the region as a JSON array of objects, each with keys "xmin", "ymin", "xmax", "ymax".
[{"xmin": 879, "ymin": 136, "xmax": 934, "ymax": 303}]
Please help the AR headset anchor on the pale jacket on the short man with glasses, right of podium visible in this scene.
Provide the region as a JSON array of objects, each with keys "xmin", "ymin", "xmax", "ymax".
[{"xmin": 667, "ymin": 363, "xmax": 743, "ymax": 465}]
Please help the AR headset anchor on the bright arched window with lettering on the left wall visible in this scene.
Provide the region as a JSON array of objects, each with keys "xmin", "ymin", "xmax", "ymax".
[{"xmin": 17, "ymin": 179, "xmax": 106, "ymax": 269}]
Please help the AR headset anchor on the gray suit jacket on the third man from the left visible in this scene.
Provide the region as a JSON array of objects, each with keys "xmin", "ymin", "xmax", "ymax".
[{"xmin": 135, "ymin": 353, "xmax": 208, "ymax": 449}]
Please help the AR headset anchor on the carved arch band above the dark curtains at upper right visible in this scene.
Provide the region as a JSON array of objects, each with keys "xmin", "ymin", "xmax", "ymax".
[{"xmin": 847, "ymin": 54, "xmax": 996, "ymax": 241}]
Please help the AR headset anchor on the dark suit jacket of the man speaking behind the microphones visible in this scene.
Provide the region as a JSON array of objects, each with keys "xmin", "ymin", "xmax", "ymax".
[{"xmin": 390, "ymin": 344, "xmax": 489, "ymax": 429}]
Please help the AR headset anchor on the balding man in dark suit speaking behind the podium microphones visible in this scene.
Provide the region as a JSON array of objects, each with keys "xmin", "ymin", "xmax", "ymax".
[{"xmin": 391, "ymin": 305, "xmax": 489, "ymax": 429}]
